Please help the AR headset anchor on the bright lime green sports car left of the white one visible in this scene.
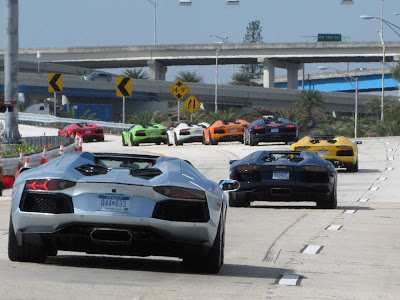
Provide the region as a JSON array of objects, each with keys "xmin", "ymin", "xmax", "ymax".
[{"xmin": 122, "ymin": 124, "xmax": 168, "ymax": 146}]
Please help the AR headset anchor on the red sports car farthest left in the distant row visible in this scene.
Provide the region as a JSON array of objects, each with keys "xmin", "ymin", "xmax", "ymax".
[{"xmin": 58, "ymin": 123, "xmax": 104, "ymax": 142}]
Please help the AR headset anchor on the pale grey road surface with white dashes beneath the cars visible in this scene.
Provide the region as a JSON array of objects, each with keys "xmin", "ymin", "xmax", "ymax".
[{"xmin": 0, "ymin": 126, "xmax": 400, "ymax": 299}]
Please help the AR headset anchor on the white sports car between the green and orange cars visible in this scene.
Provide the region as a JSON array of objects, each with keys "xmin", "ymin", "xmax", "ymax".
[{"xmin": 167, "ymin": 122, "xmax": 210, "ymax": 146}]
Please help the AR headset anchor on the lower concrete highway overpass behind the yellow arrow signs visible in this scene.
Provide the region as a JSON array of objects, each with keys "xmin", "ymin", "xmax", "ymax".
[{"xmin": 0, "ymin": 73, "xmax": 384, "ymax": 122}]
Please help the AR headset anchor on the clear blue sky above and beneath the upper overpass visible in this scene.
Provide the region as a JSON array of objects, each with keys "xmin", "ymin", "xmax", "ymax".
[{"xmin": 0, "ymin": 0, "xmax": 400, "ymax": 83}]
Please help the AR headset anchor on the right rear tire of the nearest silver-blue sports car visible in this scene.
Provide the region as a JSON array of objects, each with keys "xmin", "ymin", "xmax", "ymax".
[{"xmin": 183, "ymin": 215, "xmax": 225, "ymax": 274}]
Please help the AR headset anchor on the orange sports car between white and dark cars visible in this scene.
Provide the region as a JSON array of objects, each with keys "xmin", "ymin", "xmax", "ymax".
[{"xmin": 203, "ymin": 120, "xmax": 250, "ymax": 145}]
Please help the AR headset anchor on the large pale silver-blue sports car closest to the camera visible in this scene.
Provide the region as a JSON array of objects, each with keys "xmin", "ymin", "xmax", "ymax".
[{"xmin": 8, "ymin": 152, "xmax": 238, "ymax": 273}]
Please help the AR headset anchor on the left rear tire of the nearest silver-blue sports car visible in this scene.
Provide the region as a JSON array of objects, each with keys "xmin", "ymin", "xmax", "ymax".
[{"xmin": 8, "ymin": 216, "xmax": 47, "ymax": 263}]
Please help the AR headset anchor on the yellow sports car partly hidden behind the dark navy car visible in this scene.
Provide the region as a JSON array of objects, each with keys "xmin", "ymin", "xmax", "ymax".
[{"xmin": 290, "ymin": 135, "xmax": 362, "ymax": 172}]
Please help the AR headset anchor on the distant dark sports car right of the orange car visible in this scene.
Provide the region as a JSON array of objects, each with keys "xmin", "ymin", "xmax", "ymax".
[{"xmin": 244, "ymin": 116, "xmax": 298, "ymax": 146}]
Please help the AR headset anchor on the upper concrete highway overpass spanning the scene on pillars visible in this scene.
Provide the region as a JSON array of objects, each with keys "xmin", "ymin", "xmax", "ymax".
[{"xmin": 0, "ymin": 42, "xmax": 400, "ymax": 89}]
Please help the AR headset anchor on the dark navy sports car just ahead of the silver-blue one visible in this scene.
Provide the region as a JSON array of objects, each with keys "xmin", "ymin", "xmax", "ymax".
[{"xmin": 229, "ymin": 151, "xmax": 337, "ymax": 209}]
